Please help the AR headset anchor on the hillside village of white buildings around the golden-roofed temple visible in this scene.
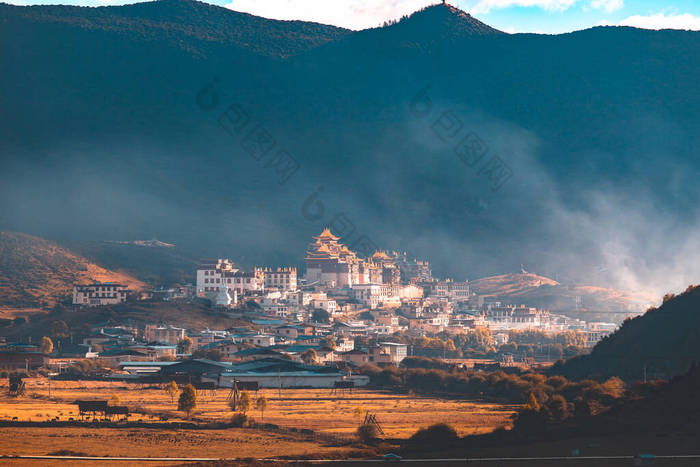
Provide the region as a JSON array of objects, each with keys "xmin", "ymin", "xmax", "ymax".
[{"xmin": 0, "ymin": 229, "xmax": 616, "ymax": 387}]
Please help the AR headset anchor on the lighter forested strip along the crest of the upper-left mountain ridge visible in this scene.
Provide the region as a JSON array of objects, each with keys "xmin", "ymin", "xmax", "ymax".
[{"xmin": 0, "ymin": 0, "xmax": 350, "ymax": 57}]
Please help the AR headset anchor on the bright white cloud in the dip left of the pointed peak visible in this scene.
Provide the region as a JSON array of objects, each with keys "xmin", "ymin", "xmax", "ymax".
[{"xmin": 225, "ymin": 0, "xmax": 438, "ymax": 29}]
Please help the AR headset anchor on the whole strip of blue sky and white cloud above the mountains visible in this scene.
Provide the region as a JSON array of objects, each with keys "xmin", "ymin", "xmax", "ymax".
[{"xmin": 4, "ymin": 0, "xmax": 700, "ymax": 33}]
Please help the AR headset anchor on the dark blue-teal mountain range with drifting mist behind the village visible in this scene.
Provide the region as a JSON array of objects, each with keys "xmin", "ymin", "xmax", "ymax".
[{"xmin": 0, "ymin": 0, "xmax": 700, "ymax": 302}]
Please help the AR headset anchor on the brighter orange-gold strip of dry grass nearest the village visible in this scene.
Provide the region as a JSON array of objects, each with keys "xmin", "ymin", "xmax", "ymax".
[{"xmin": 0, "ymin": 378, "xmax": 515, "ymax": 438}]
